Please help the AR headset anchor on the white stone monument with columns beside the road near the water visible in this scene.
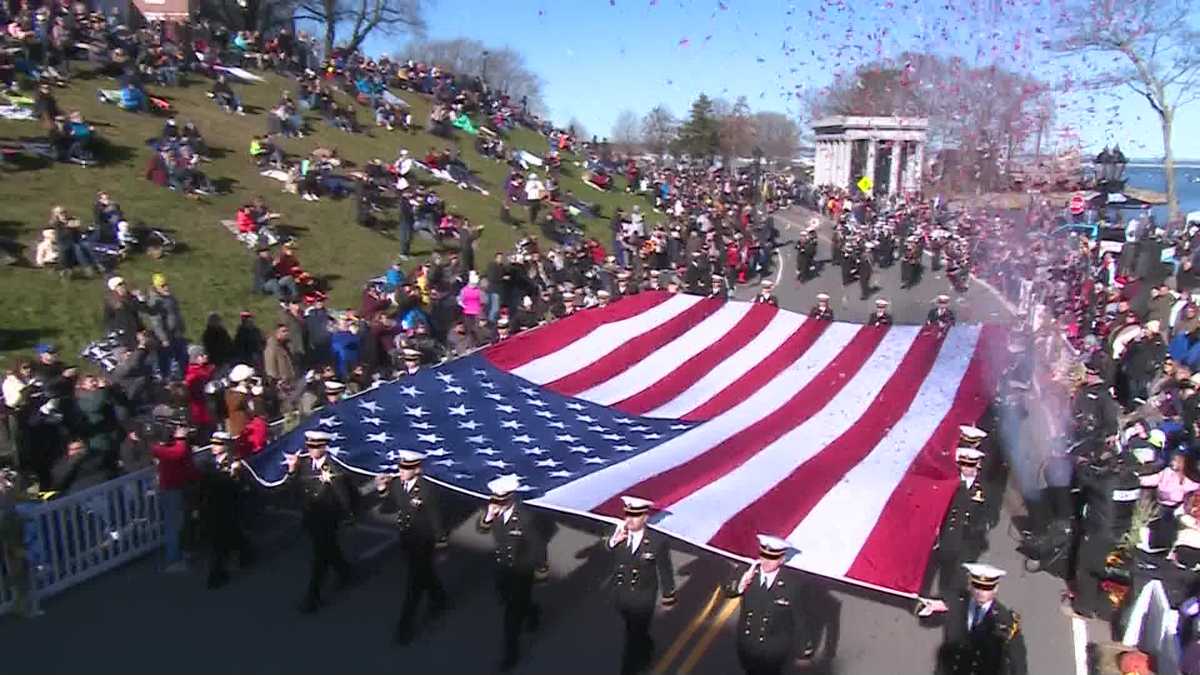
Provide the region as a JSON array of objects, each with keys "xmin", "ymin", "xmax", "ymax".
[{"xmin": 812, "ymin": 115, "xmax": 929, "ymax": 195}]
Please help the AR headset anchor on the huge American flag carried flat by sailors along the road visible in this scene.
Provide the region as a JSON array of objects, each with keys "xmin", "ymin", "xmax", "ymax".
[{"xmin": 252, "ymin": 292, "xmax": 1003, "ymax": 595}]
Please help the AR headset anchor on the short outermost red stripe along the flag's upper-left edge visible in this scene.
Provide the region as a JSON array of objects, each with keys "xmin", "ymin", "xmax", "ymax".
[{"xmin": 484, "ymin": 291, "xmax": 672, "ymax": 371}]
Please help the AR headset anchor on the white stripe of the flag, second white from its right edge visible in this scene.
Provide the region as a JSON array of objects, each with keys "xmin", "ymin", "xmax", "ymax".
[{"xmin": 650, "ymin": 325, "xmax": 920, "ymax": 542}]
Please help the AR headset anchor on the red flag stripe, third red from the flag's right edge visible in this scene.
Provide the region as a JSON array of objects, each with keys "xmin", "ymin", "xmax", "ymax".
[{"xmin": 595, "ymin": 321, "xmax": 887, "ymax": 514}]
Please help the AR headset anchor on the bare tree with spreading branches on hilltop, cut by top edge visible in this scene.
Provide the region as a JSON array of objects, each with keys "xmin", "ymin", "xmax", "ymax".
[{"xmin": 295, "ymin": 0, "xmax": 426, "ymax": 54}]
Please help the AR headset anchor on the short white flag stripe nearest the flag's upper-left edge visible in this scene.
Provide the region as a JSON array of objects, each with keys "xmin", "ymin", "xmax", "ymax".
[{"xmin": 512, "ymin": 293, "xmax": 703, "ymax": 384}]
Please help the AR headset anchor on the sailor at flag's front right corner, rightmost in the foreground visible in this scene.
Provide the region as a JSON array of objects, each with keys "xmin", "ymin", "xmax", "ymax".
[{"xmin": 918, "ymin": 562, "xmax": 1028, "ymax": 675}]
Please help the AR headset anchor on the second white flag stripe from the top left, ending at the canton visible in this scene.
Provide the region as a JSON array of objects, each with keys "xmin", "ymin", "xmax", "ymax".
[{"xmin": 578, "ymin": 303, "xmax": 754, "ymax": 406}]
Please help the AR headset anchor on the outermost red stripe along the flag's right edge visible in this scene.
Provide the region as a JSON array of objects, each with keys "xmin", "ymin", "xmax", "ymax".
[{"xmin": 846, "ymin": 325, "xmax": 1004, "ymax": 592}]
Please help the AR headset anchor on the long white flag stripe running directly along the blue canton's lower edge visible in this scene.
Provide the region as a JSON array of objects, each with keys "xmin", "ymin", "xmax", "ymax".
[{"xmin": 533, "ymin": 312, "xmax": 864, "ymax": 510}]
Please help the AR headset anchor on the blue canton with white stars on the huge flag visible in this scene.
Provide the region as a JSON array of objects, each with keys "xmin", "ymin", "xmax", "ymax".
[{"xmin": 248, "ymin": 354, "xmax": 696, "ymax": 498}]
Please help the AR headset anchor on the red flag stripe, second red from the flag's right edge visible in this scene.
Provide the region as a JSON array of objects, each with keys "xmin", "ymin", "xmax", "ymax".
[{"xmin": 708, "ymin": 328, "xmax": 942, "ymax": 551}]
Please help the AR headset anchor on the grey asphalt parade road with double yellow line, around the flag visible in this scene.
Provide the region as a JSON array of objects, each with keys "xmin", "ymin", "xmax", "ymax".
[{"xmin": 0, "ymin": 207, "xmax": 1075, "ymax": 675}]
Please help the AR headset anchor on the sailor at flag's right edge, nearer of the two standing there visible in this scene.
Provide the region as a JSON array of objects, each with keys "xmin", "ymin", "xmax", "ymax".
[{"xmin": 934, "ymin": 448, "xmax": 989, "ymax": 596}]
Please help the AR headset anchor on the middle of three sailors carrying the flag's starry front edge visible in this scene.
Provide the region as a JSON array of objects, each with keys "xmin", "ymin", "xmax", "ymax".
[{"xmin": 376, "ymin": 450, "xmax": 446, "ymax": 644}]
